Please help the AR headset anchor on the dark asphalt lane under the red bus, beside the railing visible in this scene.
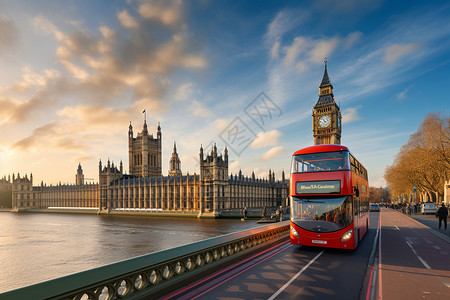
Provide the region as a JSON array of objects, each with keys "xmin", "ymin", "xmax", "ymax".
[{"xmin": 162, "ymin": 213, "xmax": 379, "ymax": 300}]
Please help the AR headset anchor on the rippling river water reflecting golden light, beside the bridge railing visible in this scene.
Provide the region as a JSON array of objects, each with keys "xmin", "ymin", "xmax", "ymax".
[{"xmin": 0, "ymin": 212, "xmax": 259, "ymax": 293}]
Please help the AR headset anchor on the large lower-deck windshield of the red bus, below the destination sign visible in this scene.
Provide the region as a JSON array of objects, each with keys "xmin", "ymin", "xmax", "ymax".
[{"xmin": 291, "ymin": 196, "xmax": 353, "ymax": 232}]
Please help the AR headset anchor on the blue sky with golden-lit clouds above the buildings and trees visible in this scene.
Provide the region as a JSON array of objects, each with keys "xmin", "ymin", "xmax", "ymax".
[{"xmin": 0, "ymin": 0, "xmax": 450, "ymax": 187}]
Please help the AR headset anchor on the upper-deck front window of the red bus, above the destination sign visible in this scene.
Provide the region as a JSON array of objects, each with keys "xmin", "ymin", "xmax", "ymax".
[{"xmin": 291, "ymin": 151, "xmax": 350, "ymax": 173}]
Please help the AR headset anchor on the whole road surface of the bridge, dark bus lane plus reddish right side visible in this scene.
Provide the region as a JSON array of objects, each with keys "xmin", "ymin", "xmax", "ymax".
[{"xmin": 161, "ymin": 209, "xmax": 450, "ymax": 300}]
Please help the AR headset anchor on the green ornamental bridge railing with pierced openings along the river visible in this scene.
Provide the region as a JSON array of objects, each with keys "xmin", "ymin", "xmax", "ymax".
[{"xmin": 0, "ymin": 221, "xmax": 289, "ymax": 300}]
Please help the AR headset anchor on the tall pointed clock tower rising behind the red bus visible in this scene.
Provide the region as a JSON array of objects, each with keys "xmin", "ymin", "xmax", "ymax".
[{"xmin": 312, "ymin": 57, "xmax": 342, "ymax": 145}]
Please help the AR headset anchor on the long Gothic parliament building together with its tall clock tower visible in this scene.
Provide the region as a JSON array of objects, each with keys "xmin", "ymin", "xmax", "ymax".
[{"xmin": 0, "ymin": 60, "xmax": 341, "ymax": 217}]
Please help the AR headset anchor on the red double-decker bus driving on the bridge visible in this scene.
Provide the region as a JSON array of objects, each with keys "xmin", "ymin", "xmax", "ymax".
[{"xmin": 289, "ymin": 145, "xmax": 369, "ymax": 249}]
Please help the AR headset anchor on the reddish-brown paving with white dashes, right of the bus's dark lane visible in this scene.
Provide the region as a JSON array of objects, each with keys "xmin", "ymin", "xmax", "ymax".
[{"xmin": 371, "ymin": 209, "xmax": 450, "ymax": 299}]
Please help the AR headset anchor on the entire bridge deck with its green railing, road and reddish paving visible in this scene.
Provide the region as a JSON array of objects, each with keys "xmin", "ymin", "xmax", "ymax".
[{"xmin": 0, "ymin": 209, "xmax": 450, "ymax": 299}]
